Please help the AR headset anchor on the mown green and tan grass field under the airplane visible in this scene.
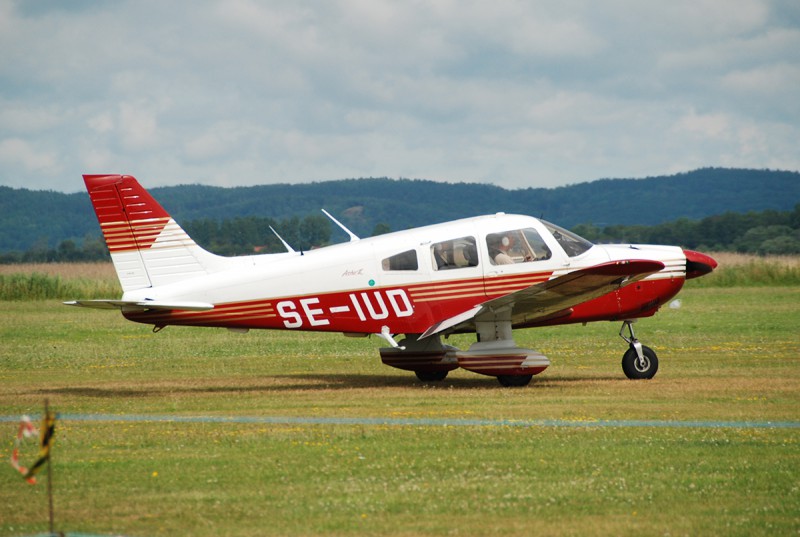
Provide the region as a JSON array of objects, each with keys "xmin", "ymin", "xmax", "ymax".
[{"xmin": 0, "ymin": 262, "xmax": 800, "ymax": 537}]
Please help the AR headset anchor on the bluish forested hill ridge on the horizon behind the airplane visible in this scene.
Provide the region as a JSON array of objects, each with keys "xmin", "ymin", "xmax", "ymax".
[{"xmin": 0, "ymin": 168, "xmax": 800, "ymax": 252}]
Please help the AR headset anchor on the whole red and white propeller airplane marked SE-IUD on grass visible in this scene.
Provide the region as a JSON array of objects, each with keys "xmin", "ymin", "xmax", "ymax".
[{"xmin": 65, "ymin": 175, "xmax": 717, "ymax": 386}]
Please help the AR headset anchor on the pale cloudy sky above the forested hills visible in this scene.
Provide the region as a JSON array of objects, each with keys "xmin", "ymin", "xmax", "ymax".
[{"xmin": 0, "ymin": 0, "xmax": 800, "ymax": 192}]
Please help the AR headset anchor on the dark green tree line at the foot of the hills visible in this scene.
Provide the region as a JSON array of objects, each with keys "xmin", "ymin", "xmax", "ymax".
[{"xmin": 0, "ymin": 203, "xmax": 800, "ymax": 264}]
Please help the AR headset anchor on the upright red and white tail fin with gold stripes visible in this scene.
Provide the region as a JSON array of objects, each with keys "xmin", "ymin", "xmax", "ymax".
[{"xmin": 83, "ymin": 175, "xmax": 223, "ymax": 292}]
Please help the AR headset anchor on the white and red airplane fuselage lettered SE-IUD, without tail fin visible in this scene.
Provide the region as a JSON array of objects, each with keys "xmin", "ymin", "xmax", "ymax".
[{"xmin": 123, "ymin": 214, "xmax": 686, "ymax": 334}]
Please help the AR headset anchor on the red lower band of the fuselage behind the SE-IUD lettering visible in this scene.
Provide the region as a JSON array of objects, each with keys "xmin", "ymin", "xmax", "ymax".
[{"xmin": 125, "ymin": 273, "xmax": 684, "ymax": 334}]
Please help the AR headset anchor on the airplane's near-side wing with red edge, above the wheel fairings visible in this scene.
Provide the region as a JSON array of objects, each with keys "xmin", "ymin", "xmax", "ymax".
[{"xmin": 420, "ymin": 260, "xmax": 664, "ymax": 338}]
